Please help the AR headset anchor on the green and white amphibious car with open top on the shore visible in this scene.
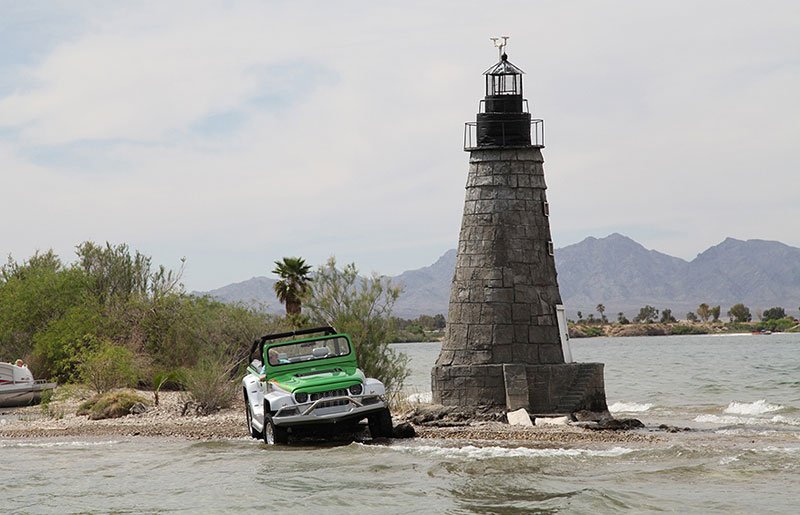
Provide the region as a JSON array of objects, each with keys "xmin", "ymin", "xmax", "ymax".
[{"xmin": 242, "ymin": 327, "xmax": 392, "ymax": 445}]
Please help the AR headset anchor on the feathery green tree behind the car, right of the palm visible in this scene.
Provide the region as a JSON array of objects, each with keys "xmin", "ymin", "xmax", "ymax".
[{"xmin": 306, "ymin": 257, "xmax": 409, "ymax": 398}]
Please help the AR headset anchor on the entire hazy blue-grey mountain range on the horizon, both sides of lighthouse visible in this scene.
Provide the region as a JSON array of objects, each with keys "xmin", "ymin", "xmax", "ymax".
[{"xmin": 199, "ymin": 233, "xmax": 800, "ymax": 319}]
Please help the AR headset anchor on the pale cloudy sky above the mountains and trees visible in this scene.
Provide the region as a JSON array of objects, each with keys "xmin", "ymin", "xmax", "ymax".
[{"xmin": 0, "ymin": 0, "xmax": 800, "ymax": 290}]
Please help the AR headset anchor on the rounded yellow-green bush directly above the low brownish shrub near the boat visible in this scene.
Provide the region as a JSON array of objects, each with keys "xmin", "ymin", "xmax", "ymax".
[{"xmin": 80, "ymin": 342, "xmax": 137, "ymax": 394}]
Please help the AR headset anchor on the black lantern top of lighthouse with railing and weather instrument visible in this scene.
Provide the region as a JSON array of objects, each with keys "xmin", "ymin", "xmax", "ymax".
[{"xmin": 464, "ymin": 38, "xmax": 544, "ymax": 150}]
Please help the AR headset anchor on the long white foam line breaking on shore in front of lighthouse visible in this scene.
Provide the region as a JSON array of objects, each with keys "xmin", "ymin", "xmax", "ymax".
[{"xmin": 389, "ymin": 445, "xmax": 634, "ymax": 459}]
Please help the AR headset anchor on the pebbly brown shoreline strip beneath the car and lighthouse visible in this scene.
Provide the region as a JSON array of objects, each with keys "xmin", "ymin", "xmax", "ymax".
[{"xmin": 0, "ymin": 392, "xmax": 664, "ymax": 445}]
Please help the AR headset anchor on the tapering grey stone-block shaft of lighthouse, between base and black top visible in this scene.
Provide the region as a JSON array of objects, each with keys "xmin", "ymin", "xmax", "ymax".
[{"xmin": 437, "ymin": 147, "xmax": 564, "ymax": 366}]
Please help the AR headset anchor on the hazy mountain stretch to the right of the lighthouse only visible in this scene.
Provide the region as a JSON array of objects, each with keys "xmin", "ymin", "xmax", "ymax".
[{"xmin": 556, "ymin": 234, "xmax": 800, "ymax": 318}]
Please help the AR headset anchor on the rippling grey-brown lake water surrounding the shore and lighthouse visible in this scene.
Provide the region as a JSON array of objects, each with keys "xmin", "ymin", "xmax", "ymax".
[{"xmin": 0, "ymin": 334, "xmax": 800, "ymax": 513}]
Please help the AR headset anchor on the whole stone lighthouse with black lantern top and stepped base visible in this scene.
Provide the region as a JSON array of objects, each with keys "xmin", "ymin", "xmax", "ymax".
[{"xmin": 431, "ymin": 38, "xmax": 607, "ymax": 420}]
